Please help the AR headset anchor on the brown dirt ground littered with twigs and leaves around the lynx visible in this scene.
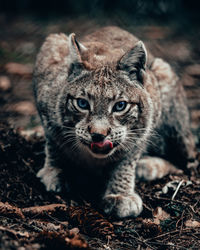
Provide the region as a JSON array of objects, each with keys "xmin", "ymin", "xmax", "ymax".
[{"xmin": 0, "ymin": 15, "xmax": 200, "ymax": 250}]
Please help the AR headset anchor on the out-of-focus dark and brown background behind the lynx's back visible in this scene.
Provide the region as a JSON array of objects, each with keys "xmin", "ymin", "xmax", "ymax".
[{"xmin": 0, "ymin": 0, "xmax": 200, "ymax": 144}]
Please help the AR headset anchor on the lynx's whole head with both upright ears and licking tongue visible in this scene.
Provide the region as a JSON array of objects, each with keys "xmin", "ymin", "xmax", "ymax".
[{"xmin": 59, "ymin": 34, "xmax": 152, "ymax": 159}]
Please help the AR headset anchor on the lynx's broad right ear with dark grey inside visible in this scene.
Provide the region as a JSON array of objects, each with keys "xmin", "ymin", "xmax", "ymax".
[{"xmin": 118, "ymin": 41, "xmax": 147, "ymax": 80}]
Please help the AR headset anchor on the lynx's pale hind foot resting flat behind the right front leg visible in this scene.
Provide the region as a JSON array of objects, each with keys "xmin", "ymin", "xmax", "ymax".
[{"xmin": 136, "ymin": 156, "xmax": 182, "ymax": 181}]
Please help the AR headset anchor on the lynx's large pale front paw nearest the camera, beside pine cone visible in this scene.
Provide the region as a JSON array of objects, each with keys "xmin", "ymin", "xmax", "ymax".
[{"xmin": 103, "ymin": 193, "xmax": 142, "ymax": 218}]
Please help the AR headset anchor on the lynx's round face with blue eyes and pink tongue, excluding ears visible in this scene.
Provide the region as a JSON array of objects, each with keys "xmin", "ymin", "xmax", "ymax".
[{"xmin": 62, "ymin": 67, "xmax": 151, "ymax": 158}]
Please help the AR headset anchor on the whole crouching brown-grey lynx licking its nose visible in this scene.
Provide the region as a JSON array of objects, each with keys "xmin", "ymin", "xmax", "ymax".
[{"xmin": 33, "ymin": 27, "xmax": 196, "ymax": 218}]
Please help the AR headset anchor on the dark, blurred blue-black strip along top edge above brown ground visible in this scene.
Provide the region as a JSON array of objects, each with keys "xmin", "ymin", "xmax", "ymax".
[{"xmin": 0, "ymin": 0, "xmax": 200, "ymax": 23}]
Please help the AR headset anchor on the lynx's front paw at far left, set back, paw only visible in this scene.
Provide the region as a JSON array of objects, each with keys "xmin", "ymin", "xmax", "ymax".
[{"xmin": 37, "ymin": 167, "xmax": 62, "ymax": 192}]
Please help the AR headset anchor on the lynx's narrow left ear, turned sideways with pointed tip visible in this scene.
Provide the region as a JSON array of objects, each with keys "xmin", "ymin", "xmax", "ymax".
[{"xmin": 68, "ymin": 33, "xmax": 87, "ymax": 76}]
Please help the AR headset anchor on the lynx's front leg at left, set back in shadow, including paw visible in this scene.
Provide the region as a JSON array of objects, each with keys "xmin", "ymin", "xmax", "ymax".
[{"xmin": 37, "ymin": 143, "xmax": 62, "ymax": 192}]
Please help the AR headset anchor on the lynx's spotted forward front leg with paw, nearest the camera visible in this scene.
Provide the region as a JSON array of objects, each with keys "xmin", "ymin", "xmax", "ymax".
[{"xmin": 103, "ymin": 161, "xmax": 142, "ymax": 218}]
